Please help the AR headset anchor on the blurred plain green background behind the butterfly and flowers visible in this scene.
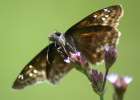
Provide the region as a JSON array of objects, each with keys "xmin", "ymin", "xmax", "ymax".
[{"xmin": 0, "ymin": 0, "xmax": 140, "ymax": 100}]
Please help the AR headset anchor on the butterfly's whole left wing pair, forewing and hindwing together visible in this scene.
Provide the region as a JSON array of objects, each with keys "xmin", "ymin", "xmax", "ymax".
[{"xmin": 13, "ymin": 44, "xmax": 72, "ymax": 89}]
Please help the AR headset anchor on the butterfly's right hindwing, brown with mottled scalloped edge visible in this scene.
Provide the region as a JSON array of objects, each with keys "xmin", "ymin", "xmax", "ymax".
[{"xmin": 66, "ymin": 26, "xmax": 119, "ymax": 64}]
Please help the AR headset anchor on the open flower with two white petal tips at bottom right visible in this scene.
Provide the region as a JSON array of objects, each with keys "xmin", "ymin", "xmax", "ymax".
[{"xmin": 107, "ymin": 74, "xmax": 132, "ymax": 96}]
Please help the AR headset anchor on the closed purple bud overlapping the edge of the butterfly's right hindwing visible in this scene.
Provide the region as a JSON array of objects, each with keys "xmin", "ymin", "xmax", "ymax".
[{"xmin": 104, "ymin": 46, "xmax": 117, "ymax": 68}]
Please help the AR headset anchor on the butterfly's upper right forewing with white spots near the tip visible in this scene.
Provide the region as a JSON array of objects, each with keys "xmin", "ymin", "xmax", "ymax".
[{"xmin": 66, "ymin": 5, "xmax": 123, "ymax": 33}]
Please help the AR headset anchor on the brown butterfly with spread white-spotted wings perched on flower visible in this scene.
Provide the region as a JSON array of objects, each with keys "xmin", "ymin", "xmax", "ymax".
[{"xmin": 12, "ymin": 5, "xmax": 123, "ymax": 89}]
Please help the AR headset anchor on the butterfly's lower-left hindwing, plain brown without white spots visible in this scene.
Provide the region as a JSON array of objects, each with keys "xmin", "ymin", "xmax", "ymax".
[{"xmin": 47, "ymin": 43, "xmax": 73, "ymax": 84}]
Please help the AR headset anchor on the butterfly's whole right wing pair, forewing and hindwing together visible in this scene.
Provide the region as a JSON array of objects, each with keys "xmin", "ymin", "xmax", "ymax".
[{"xmin": 65, "ymin": 5, "xmax": 123, "ymax": 64}]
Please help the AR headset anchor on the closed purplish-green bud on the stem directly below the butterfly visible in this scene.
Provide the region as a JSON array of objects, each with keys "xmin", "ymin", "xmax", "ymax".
[{"xmin": 91, "ymin": 69, "xmax": 103, "ymax": 95}]
